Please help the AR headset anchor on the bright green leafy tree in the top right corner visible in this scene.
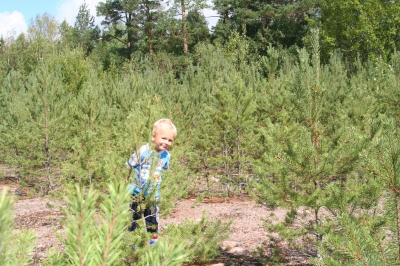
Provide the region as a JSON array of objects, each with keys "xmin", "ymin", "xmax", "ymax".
[{"xmin": 319, "ymin": 0, "xmax": 400, "ymax": 61}]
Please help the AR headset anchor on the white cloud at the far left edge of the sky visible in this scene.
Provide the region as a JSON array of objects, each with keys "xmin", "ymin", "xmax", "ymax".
[{"xmin": 0, "ymin": 11, "xmax": 28, "ymax": 38}]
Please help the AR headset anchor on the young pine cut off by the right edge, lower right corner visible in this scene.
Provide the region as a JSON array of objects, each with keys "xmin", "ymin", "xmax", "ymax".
[{"xmin": 312, "ymin": 117, "xmax": 400, "ymax": 265}]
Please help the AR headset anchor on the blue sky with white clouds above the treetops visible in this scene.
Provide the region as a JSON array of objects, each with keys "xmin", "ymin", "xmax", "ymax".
[{"xmin": 0, "ymin": 0, "xmax": 216, "ymax": 38}]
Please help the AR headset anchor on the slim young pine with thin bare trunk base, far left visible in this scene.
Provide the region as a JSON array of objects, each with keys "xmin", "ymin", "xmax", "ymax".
[{"xmin": 24, "ymin": 64, "xmax": 68, "ymax": 188}]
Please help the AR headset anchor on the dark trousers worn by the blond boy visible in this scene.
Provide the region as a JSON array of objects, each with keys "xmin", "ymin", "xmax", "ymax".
[{"xmin": 128, "ymin": 199, "xmax": 159, "ymax": 233}]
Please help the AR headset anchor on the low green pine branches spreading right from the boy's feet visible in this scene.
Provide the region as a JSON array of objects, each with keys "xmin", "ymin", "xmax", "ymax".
[{"xmin": 123, "ymin": 211, "xmax": 231, "ymax": 265}]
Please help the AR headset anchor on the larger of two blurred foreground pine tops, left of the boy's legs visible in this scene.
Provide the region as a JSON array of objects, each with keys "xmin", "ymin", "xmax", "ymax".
[{"xmin": 44, "ymin": 182, "xmax": 130, "ymax": 265}]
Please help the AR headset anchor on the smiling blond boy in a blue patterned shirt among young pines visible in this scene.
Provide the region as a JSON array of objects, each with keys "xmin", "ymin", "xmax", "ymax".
[{"xmin": 126, "ymin": 118, "xmax": 177, "ymax": 233}]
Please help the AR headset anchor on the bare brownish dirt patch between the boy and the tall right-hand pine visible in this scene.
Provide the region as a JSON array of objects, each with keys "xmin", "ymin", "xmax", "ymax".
[{"xmin": 160, "ymin": 197, "xmax": 311, "ymax": 266}]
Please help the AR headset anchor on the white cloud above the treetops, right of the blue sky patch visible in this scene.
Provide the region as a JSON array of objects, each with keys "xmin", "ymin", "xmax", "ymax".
[{"xmin": 56, "ymin": 0, "xmax": 106, "ymax": 26}]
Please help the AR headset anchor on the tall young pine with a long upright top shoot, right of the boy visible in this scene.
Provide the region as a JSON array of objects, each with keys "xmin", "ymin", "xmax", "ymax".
[{"xmin": 250, "ymin": 31, "xmax": 380, "ymax": 258}]
